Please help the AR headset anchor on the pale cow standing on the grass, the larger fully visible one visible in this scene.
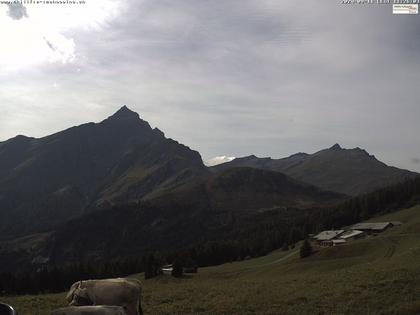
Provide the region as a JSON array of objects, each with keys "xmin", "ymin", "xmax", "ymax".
[{"xmin": 66, "ymin": 278, "xmax": 143, "ymax": 315}]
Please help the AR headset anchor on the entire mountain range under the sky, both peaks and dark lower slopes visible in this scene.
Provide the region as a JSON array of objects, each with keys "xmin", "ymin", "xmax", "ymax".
[{"xmin": 0, "ymin": 106, "xmax": 415, "ymax": 271}]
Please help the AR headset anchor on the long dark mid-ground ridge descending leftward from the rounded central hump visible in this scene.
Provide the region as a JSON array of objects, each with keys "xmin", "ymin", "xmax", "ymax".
[{"xmin": 20, "ymin": 168, "xmax": 344, "ymax": 265}]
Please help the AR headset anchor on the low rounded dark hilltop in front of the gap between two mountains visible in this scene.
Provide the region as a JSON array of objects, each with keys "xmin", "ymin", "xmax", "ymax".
[{"xmin": 145, "ymin": 167, "xmax": 346, "ymax": 212}]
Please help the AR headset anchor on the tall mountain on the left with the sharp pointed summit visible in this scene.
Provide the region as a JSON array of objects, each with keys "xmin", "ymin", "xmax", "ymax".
[{"xmin": 0, "ymin": 106, "xmax": 207, "ymax": 239}]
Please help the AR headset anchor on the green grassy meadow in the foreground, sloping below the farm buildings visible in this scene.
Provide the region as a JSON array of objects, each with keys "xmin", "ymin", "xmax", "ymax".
[{"xmin": 0, "ymin": 206, "xmax": 420, "ymax": 315}]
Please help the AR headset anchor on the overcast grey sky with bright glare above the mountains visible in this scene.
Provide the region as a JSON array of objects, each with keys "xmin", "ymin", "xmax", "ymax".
[{"xmin": 0, "ymin": 0, "xmax": 420, "ymax": 171}]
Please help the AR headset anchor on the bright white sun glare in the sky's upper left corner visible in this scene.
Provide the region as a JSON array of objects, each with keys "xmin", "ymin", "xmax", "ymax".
[{"xmin": 0, "ymin": 0, "xmax": 120, "ymax": 71}]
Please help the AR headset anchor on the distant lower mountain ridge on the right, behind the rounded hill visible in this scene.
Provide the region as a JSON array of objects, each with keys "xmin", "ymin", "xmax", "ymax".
[{"xmin": 210, "ymin": 144, "xmax": 418, "ymax": 196}]
